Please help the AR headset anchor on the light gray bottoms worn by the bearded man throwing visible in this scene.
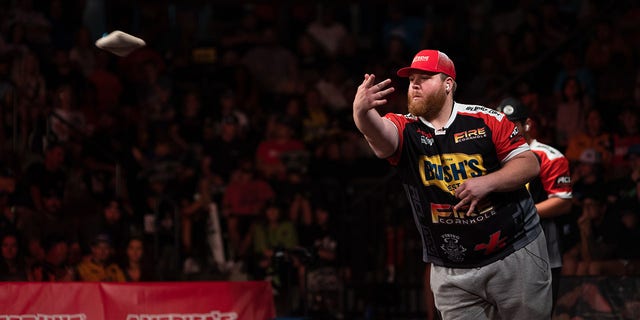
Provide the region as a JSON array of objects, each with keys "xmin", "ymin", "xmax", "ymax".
[{"xmin": 431, "ymin": 233, "xmax": 551, "ymax": 320}]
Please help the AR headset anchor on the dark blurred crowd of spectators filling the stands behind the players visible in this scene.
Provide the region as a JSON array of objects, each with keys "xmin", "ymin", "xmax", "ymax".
[{"xmin": 0, "ymin": 0, "xmax": 640, "ymax": 318}]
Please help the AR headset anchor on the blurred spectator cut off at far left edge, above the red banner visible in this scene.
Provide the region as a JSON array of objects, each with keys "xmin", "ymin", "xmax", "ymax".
[{"xmin": 0, "ymin": 233, "xmax": 28, "ymax": 281}]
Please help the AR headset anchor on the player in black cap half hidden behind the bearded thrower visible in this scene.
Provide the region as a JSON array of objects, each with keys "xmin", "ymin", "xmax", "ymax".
[{"xmin": 497, "ymin": 98, "xmax": 572, "ymax": 306}]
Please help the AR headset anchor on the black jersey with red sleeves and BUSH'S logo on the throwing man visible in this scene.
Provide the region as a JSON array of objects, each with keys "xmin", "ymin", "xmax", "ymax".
[{"xmin": 385, "ymin": 103, "xmax": 542, "ymax": 268}]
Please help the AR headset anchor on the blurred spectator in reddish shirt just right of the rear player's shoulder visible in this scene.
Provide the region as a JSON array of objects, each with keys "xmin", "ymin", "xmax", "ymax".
[{"xmin": 560, "ymin": 109, "xmax": 612, "ymax": 167}]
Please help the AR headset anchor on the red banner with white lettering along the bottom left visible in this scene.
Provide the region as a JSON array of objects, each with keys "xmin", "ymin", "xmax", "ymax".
[{"xmin": 0, "ymin": 281, "xmax": 275, "ymax": 320}]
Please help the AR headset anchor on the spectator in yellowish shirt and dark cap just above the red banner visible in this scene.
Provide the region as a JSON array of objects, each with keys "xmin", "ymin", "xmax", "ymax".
[{"xmin": 77, "ymin": 234, "xmax": 126, "ymax": 282}]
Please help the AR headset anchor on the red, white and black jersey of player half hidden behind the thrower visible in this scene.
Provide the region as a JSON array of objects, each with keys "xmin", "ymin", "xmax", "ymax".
[{"xmin": 529, "ymin": 140, "xmax": 572, "ymax": 268}]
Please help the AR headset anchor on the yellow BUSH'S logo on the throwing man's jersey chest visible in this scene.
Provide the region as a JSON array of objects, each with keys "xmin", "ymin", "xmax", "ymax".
[{"xmin": 418, "ymin": 153, "xmax": 486, "ymax": 194}]
